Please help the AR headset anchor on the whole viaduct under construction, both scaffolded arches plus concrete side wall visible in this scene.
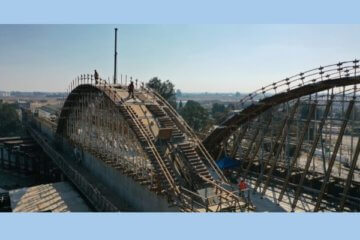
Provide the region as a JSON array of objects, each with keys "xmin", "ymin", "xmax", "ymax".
[{"xmin": 21, "ymin": 60, "xmax": 360, "ymax": 212}]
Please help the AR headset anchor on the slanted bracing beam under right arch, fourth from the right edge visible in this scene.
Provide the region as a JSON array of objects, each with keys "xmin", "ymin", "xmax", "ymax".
[{"xmin": 278, "ymin": 103, "xmax": 316, "ymax": 202}]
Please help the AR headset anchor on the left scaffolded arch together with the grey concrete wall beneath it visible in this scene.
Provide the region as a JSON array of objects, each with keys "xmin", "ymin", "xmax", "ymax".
[{"xmin": 25, "ymin": 75, "xmax": 246, "ymax": 212}]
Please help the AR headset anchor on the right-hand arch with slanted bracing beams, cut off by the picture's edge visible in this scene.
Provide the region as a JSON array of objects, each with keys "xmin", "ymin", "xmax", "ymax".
[{"xmin": 203, "ymin": 60, "xmax": 360, "ymax": 211}]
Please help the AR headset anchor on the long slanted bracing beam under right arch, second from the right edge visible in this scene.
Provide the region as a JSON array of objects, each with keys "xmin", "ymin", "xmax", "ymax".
[{"xmin": 314, "ymin": 100, "xmax": 355, "ymax": 212}]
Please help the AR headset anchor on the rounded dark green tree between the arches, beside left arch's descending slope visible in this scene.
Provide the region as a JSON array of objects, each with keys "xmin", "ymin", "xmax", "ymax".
[{"xmin": 180, "ymin": 100, "xmax": 210, "ymax": 132}]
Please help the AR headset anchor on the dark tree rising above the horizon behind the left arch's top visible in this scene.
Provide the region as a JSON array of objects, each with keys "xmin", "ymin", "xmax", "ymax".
[{"xmin": 146, "ymin": 77, "xmax": 176, "ymax": 109}]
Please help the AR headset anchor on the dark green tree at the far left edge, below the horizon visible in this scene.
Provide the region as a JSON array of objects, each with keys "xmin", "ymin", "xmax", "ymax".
[{"xmin": 0, "ymin": 102, "xmax": 23, "ymax": 137}]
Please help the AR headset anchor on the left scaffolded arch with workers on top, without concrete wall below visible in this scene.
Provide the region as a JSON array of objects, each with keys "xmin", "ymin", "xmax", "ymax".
[{"xmin": 56, "ymin": 75, "xmax": 246, "ymax": 212}]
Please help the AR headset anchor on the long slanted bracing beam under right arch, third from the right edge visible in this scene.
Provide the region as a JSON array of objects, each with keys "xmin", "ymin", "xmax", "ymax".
[{"xmin": 291, "ymin": 95, "xmax": 334, "ymax": 211}]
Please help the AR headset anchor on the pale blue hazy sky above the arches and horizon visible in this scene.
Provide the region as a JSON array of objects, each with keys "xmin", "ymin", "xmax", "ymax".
[{"xmin": 0, "ymin": 25, "xmax": 360, "ymax": 92}]
